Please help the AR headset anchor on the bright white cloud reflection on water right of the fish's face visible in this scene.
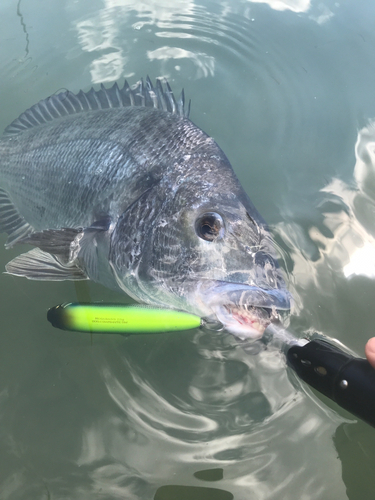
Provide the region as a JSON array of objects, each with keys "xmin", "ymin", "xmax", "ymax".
[{"xmin": 278, "ymin": 120, "xmax": 375, "ymax": 295}]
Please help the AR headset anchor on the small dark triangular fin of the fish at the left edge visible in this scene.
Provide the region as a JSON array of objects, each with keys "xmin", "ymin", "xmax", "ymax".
[{"xmin": 0, "ymin": 188, "xmax": 34, "ymax": 248}]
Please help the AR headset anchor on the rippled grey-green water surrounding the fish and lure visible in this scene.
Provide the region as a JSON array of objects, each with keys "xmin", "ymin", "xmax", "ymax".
[{"xmin": 0, "ymin": 0, "xmax": 375, "ymax": 500}]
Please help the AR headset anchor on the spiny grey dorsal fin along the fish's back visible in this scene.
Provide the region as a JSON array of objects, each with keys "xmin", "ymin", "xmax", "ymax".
[{"xmin": 4, "ymin": 77, "xmax": 194, "ymax": 135}]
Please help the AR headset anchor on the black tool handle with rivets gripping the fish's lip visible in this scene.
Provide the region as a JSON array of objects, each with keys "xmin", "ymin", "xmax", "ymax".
[{"xmin": 287, "ymin": 339, "xmax": 375, "ymax": 427}]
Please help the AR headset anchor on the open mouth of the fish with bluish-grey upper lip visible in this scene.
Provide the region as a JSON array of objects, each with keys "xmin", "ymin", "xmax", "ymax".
[{"xmin": 200, "ymin": 282, "xmax": 291, "ymax": 340}]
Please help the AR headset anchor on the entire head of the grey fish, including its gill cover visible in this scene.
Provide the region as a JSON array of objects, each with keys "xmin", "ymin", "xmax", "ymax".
[{"xmin": 110, "ymin": 154, "xmax": 290, "ymax": 339}]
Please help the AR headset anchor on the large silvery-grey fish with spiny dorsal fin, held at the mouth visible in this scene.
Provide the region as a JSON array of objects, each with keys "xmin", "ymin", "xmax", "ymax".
[{"xmin": 0, "ymin": 77, "xmax": 291, "ymax": 339}]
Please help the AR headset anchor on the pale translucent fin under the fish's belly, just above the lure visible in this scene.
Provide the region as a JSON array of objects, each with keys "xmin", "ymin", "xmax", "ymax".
[{"xmin": 5, "ymin": 248, "xmax": 88, "ymax": 281}]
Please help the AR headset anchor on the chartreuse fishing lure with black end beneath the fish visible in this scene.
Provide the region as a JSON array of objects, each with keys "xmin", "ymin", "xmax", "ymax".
[{"xmin": 47, "ymin": 303, "xmax": 202, "ymax": 334}]
